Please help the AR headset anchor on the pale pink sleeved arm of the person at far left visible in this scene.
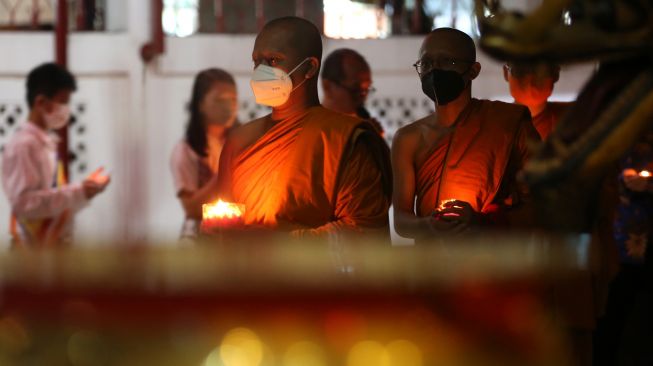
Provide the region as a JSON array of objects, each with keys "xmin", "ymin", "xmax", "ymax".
[{"xmin": 2, "ymin": 142, "xmax": 87, "ymax": 219}]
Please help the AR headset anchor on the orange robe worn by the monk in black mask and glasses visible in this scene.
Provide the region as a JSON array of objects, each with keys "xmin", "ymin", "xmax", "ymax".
[{"xmin": 416, "ymin": 99, "xmax": 539, "ymax": 220}]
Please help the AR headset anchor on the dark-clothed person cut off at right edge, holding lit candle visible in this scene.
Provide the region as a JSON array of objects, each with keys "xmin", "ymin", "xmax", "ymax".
[{"xmin": 594, "ymin": 131, "xmax": 653, "ymax": 365}]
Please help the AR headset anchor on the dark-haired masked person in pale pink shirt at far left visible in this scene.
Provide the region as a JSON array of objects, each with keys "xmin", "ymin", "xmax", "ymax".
[{"xmin": 2, "ymin": 63, "xmax": 110, "ymax": 248}]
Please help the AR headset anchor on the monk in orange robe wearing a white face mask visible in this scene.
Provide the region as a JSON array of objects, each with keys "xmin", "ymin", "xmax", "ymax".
[{"xmin": 218, "ymin": 17, "xmax": 392, "ymax": 237}]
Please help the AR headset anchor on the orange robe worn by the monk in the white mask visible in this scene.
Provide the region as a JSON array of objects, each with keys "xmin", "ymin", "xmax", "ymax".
[{"xmin": 220, "ymin": 107, "xmax": 392, "ymax": 235}]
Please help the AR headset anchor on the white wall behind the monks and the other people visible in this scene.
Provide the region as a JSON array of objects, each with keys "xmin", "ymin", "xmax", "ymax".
[{"xmin": 0, "ymin": 1, "xmax": 591, "ymax": 246}]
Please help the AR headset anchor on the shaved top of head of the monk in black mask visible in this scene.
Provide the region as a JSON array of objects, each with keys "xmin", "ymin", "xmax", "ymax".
[{"xmin": 420, "ymin": 27, "xmax": 476, "ymax": 62}]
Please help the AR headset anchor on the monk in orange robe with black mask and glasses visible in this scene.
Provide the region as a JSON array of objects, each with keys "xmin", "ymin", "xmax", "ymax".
[{"xmin": 392, "ymin": 28, "xmax": 539, "ymax": 239}]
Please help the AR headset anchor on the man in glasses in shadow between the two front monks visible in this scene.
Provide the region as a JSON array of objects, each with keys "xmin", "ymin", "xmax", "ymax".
[{"xmin": 322, "ymin": 48, "xmax": 384, "ymax": 136}]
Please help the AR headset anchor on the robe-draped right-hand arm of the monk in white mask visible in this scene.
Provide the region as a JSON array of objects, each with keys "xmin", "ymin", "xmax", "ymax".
[{"xmin": 292, "ymin": 134, "xmax": 390, "ymax": 237}]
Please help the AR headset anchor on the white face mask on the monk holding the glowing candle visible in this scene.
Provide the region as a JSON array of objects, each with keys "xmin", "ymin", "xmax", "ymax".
[{"xmin": 249, "ymin": 57, "xmax": 310, "ymax": 107}]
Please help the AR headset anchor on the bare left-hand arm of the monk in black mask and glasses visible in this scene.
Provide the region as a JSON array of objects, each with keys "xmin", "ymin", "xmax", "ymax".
[{"xmin": 392, "ymin": 130, "xmax": 453, "ymax": 238}]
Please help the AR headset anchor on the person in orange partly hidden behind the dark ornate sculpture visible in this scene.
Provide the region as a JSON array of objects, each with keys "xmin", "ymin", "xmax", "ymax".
[{"xmin": 503, "ymin": 62, "xmax": 571, "ymax": 140}]
